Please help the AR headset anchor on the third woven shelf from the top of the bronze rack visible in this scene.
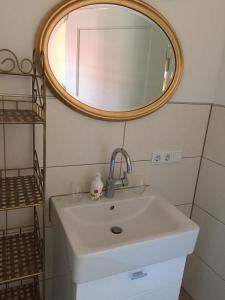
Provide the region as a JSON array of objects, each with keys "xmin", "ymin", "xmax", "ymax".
[{"xmin": 0, "ymin": 212, "xmax": 43, "ymax": 284}]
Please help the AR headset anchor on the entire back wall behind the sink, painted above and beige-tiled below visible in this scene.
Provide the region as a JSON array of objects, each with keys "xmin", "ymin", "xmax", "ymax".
[{"xmin": 0, "ymin": 0, "xmax": 225, "ymax": 300}]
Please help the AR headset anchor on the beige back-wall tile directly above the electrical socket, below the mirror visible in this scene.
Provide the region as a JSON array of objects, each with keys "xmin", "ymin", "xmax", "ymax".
[{"xmin": 125, "ymin": 104, "xmax": 210, "ymax": 160}]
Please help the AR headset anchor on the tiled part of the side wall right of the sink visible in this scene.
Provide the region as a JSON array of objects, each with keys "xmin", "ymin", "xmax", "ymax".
[{"xmin": 184, "ymin": 106, "xmax": 225, "ymax": 300}]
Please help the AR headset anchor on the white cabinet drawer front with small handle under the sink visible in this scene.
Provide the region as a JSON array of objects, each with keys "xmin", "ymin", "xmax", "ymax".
[{"xmin": 72, "ymin": 257, "xmax": 186, "ymax": 300}]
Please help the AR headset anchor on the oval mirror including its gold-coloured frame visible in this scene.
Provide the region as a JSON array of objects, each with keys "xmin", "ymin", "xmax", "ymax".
[{"xmin": 37, "ymin": 0, "xmax": 183, "ymax": 120}]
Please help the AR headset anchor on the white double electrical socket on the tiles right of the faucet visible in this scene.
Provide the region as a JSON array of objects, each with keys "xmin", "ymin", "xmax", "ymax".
[{"xmin": 152, "ymin": 151, "xmax": 182, "ymax": 164}]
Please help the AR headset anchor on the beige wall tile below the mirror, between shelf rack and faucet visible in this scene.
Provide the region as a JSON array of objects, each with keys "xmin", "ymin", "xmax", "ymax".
[{"xmin": 47, "ymin": 99, "xmax": 124, "ymax": 166}]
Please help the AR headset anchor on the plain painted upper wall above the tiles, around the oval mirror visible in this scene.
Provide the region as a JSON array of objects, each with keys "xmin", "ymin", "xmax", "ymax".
[{"xmin": 0, "ymin": 0, "xmax": 225, "ymax": 102}]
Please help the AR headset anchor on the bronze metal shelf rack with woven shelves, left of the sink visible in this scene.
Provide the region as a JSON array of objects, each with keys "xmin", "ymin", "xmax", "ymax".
[{"xmin": 0, "ymin": 49, "xmax": 46, "ymax": 300}]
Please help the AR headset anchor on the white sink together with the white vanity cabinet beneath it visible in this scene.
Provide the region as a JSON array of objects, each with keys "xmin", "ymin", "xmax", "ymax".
[{"xmin": 50, "ymin": 187, "xmax": 199, "ymax": 300}]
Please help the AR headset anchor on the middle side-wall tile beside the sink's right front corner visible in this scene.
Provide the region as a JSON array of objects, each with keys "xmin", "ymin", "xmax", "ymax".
[{"xmin": 192, "ymin": 207, "xmax": 225, "ymax": 280}]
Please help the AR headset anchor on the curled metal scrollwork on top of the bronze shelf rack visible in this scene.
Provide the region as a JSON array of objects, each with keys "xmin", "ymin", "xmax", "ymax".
[{"xmin": 0, "ymin": 49, "xmax": 33, "ymax": 74}]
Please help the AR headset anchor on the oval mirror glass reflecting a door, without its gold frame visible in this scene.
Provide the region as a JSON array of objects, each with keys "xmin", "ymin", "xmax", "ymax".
[{"xmin": 47, "ymin": 4, "xmax": 176, "ymax": 112}]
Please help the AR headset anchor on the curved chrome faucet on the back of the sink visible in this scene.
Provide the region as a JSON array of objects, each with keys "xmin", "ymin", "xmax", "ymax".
[{"xmin": 105, "ymin": 148, "xmax": 132, "ymax": 198}]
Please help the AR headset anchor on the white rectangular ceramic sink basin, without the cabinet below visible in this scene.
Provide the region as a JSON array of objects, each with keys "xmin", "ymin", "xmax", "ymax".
[{"xmin": 52, "ymin": 188, "xmax": 199, "ymax": 283}]
